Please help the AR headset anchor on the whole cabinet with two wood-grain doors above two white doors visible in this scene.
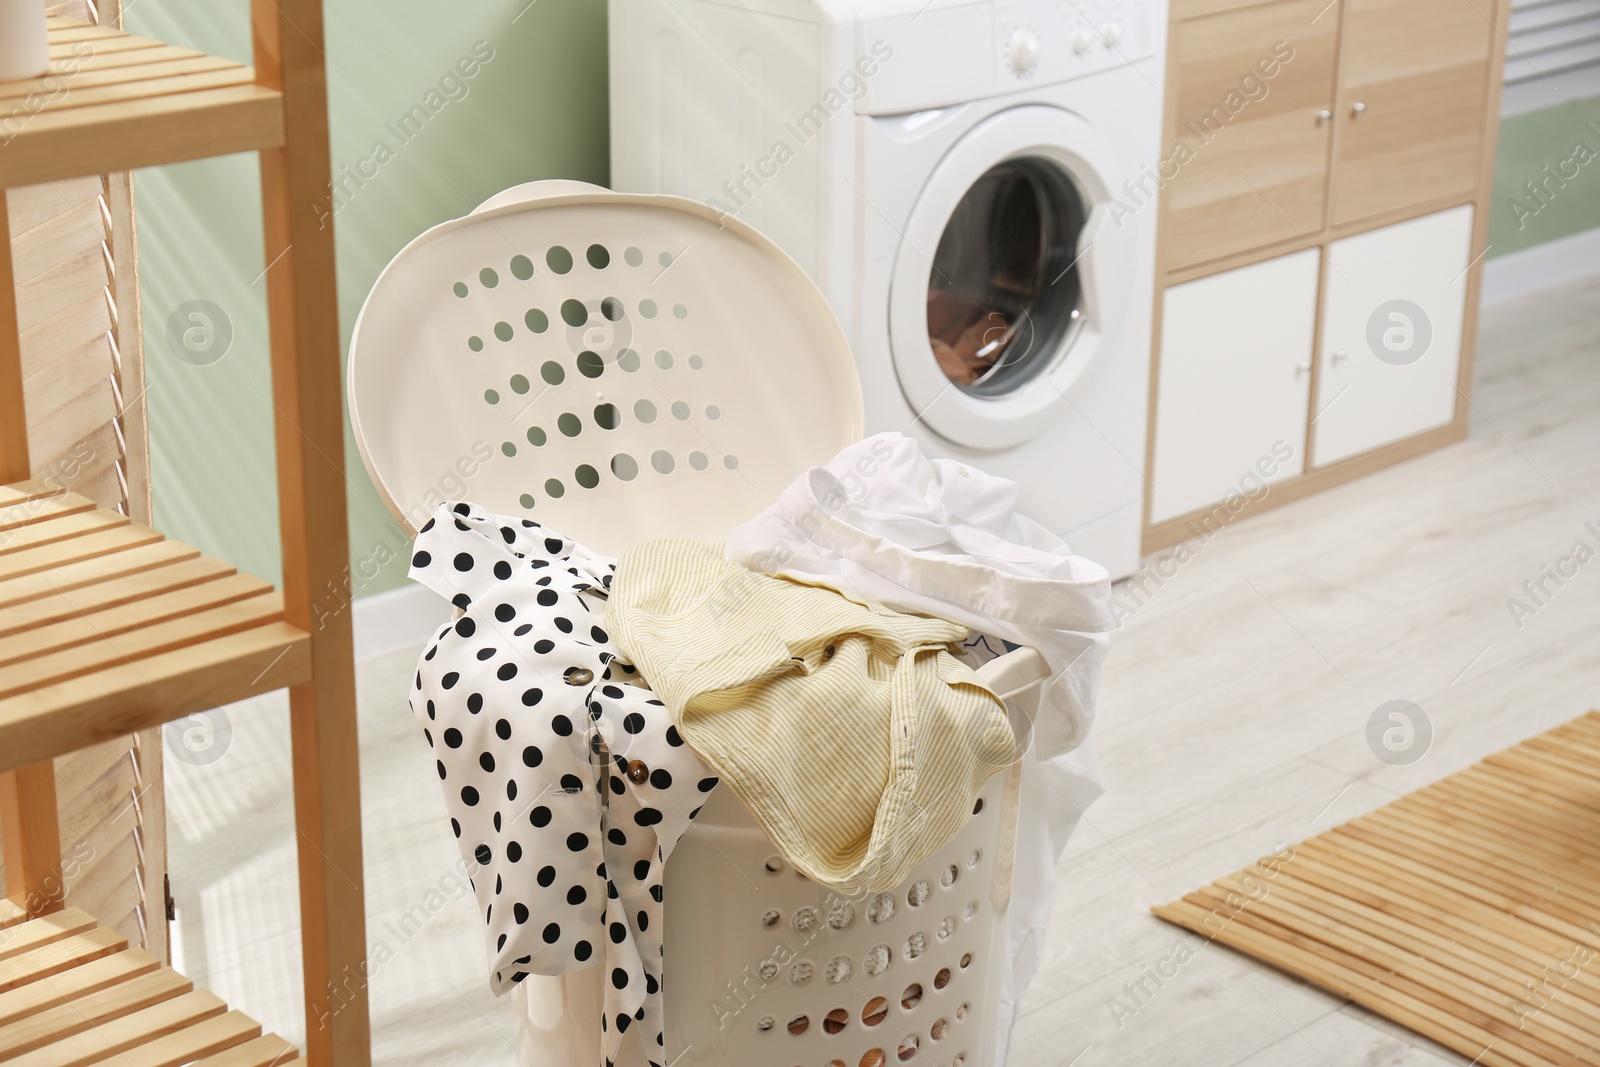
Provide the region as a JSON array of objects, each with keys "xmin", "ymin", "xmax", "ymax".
[{"xmin": 1144, "ymin": 0, "xmax": 1510, "ymax": 552}]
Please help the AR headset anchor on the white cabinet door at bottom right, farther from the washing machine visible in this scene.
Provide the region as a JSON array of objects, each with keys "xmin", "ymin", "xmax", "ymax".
[{"xmin": 1312, "ymin": 205, "xmax": 1472, "ymax": 467}]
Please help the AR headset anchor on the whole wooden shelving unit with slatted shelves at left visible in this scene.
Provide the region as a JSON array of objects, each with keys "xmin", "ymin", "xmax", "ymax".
[{"xmin": 0, "ymin": 8, "xmax": 371, "ymax": 1067}]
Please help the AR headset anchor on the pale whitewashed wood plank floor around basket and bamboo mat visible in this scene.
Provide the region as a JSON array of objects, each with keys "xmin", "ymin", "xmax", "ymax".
[{"xmin": 168, "ymin": 285, "xmax": 1600, "ymax": 1067}]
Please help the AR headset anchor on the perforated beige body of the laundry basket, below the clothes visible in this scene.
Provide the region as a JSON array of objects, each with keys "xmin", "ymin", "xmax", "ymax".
[{"xmin": 656, "ymin": 651, "xmax": 1045, "ymax": 1067}]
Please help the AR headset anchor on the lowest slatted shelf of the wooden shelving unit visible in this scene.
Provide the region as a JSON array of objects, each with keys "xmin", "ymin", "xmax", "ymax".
[{"xmin": 0, "ymin": 909, "xmax": 299, "ymax": 1067}]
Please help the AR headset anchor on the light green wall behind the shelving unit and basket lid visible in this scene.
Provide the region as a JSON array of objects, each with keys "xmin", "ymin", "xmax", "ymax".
[{"xmin": 126, "ymin": 0, "xmax": 606, "ymax": 595}]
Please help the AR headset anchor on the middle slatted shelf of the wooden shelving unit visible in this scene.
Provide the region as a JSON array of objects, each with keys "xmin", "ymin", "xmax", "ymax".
[{"xmin": 0, "ymin": 476, "xmax": 310, "ymax": 771}]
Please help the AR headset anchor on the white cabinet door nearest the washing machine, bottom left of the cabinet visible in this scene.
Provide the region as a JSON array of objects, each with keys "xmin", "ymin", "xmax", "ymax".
[{"xmin": 1150, "ymin": 255, "xmax": 1317, "ymax": 523}]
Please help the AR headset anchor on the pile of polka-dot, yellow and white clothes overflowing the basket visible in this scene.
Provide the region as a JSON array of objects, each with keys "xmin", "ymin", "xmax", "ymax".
[{"xmin": 411, "ymin": 434, "xmax": 1114, "ymax": 1064}]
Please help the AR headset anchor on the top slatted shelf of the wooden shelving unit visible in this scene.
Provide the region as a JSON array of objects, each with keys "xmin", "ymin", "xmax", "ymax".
[{"xmin": 0, "ymin": 18, "xmax": 283, "ymax": 189}]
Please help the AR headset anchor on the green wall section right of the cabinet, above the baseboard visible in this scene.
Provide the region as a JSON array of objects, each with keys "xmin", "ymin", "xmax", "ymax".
[{"xmin": 1490, "ymin": 96, "xmax": 1600, "ymax": 258}]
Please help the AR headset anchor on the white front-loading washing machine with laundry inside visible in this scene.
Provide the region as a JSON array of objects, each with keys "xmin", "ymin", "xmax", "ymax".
[{"xmin": 610, "ymin": 0, "xmax": 1171, "ymax": 577}]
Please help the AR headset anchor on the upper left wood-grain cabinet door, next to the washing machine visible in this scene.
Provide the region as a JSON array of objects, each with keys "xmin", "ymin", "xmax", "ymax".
[{"xmin": 1162, "ymin": 0, "xmax": 1339, "ymax": 264}]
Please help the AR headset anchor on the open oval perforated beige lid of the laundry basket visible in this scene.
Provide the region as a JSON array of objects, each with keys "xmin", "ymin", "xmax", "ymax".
[{"xmin": 349, "ymin": 181, "xmax": 862, "ymax": 553}]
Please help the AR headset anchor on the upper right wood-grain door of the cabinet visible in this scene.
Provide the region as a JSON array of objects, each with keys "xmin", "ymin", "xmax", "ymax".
[{"xmin": 1333, "ymin": 0, "xmax": 1504, "ymax": 226}]
